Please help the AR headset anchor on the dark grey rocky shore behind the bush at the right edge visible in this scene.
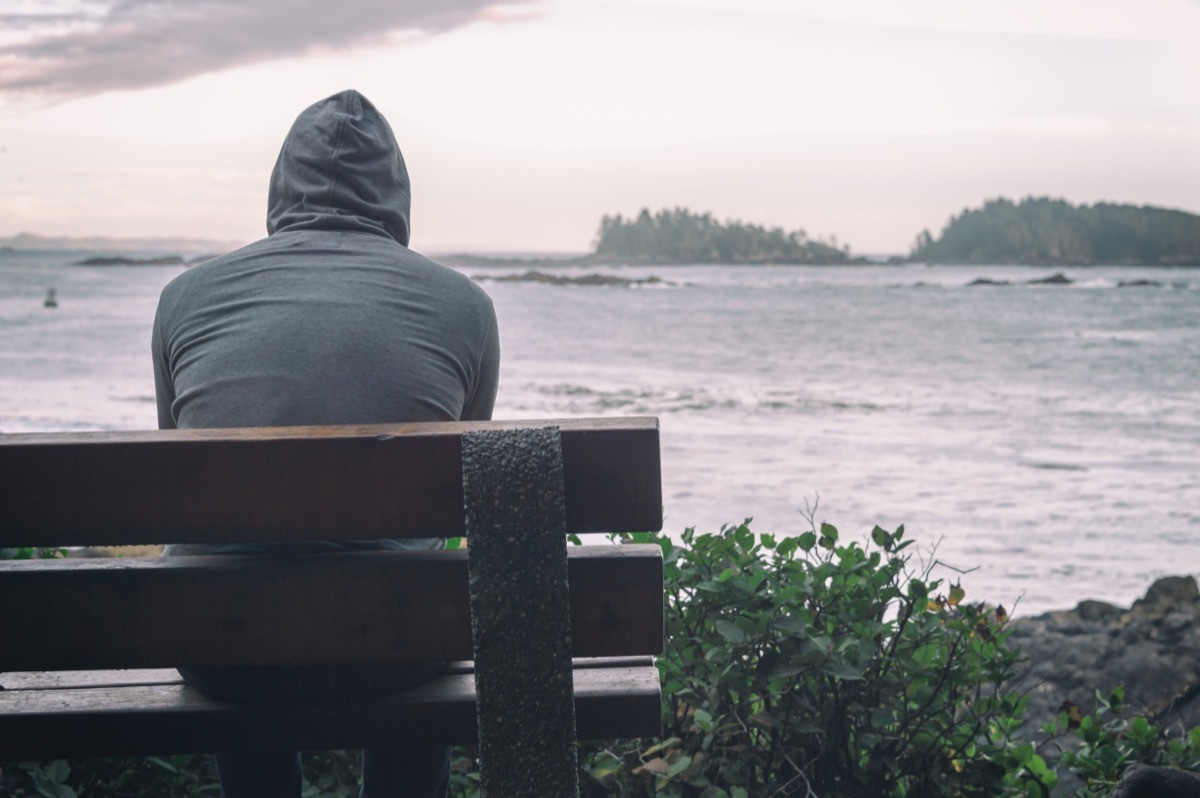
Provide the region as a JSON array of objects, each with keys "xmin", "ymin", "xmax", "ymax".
[{"xmin": 1009, "ymin": 576, "xmax": 1200, "ymax": 737}]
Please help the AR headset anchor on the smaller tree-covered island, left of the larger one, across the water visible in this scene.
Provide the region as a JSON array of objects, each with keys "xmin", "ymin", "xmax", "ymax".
[{"xmin": 595, "ymin": 208, "xmax": 852, "ymax": 264}]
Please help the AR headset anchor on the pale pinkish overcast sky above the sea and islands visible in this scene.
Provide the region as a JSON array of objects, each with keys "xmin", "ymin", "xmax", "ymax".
[{"xmin": 0, "ymin": 0, "xmax": 1200, "ymax": 253}]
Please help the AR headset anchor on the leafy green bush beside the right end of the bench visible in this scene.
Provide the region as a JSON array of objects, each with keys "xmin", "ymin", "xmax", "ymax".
[{"xmin": 586, "ymin": 523, "xmax": 1032, "ymax": 798}]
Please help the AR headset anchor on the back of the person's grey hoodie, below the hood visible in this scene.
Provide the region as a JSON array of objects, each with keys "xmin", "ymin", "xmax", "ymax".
[{"xmin": 154, "ymin": 230, "xmax": 498, "ymax": 428}]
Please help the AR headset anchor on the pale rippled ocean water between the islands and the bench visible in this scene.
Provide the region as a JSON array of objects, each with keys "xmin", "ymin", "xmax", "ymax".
[{"xmin": 0, "ymin": 252, "xmax": 1200, "ymax": 614}]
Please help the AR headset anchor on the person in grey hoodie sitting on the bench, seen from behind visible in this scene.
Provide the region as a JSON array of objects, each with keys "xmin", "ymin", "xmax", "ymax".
[{"xmin": 151, "ymin": 91, "xmax": 499, "ymax": 798}]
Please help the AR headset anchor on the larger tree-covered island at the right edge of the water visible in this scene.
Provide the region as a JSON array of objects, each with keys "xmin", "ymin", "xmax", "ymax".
[{"xmin": 910, "ymin": 197, "xmax": 1200, "ymax": 266}]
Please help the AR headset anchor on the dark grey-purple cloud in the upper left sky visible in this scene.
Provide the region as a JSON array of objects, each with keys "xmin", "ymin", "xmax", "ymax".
[{"xmin": 0, "ymin": 0, "xmax": 535, "ymax": 98}]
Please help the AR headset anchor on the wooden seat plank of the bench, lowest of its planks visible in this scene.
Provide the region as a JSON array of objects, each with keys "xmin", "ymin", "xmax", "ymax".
[{"xmin": 0, "ymin": 660, "xmax": 660, "ymax": 761}]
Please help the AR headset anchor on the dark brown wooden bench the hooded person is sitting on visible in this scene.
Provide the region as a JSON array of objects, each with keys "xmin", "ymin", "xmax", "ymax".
[{"xmin": 0, "ymin": 418, "xmax": 662, "ymax": 794}]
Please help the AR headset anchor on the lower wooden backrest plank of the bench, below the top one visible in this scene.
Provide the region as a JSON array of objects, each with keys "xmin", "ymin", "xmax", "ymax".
[{"xmin": 0, "ymin": 545, "xmax": 662, "ymax": 671}]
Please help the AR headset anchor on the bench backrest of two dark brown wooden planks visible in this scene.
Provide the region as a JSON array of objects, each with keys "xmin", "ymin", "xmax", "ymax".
[{"xmin": 0, "ymin": 419, "xmax": 662, "ymax": 671}]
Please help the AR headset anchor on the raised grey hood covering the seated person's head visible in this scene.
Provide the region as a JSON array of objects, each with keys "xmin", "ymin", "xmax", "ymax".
[{"xmin": 266, "ymin": 90, "xmax": 412, "ymax": 246}]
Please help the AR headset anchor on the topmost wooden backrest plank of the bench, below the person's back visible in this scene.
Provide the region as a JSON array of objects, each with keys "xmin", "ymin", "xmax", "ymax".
[{"xmin": 0, "ymin": 418, "xmax": 662, "ymax": 546}]
